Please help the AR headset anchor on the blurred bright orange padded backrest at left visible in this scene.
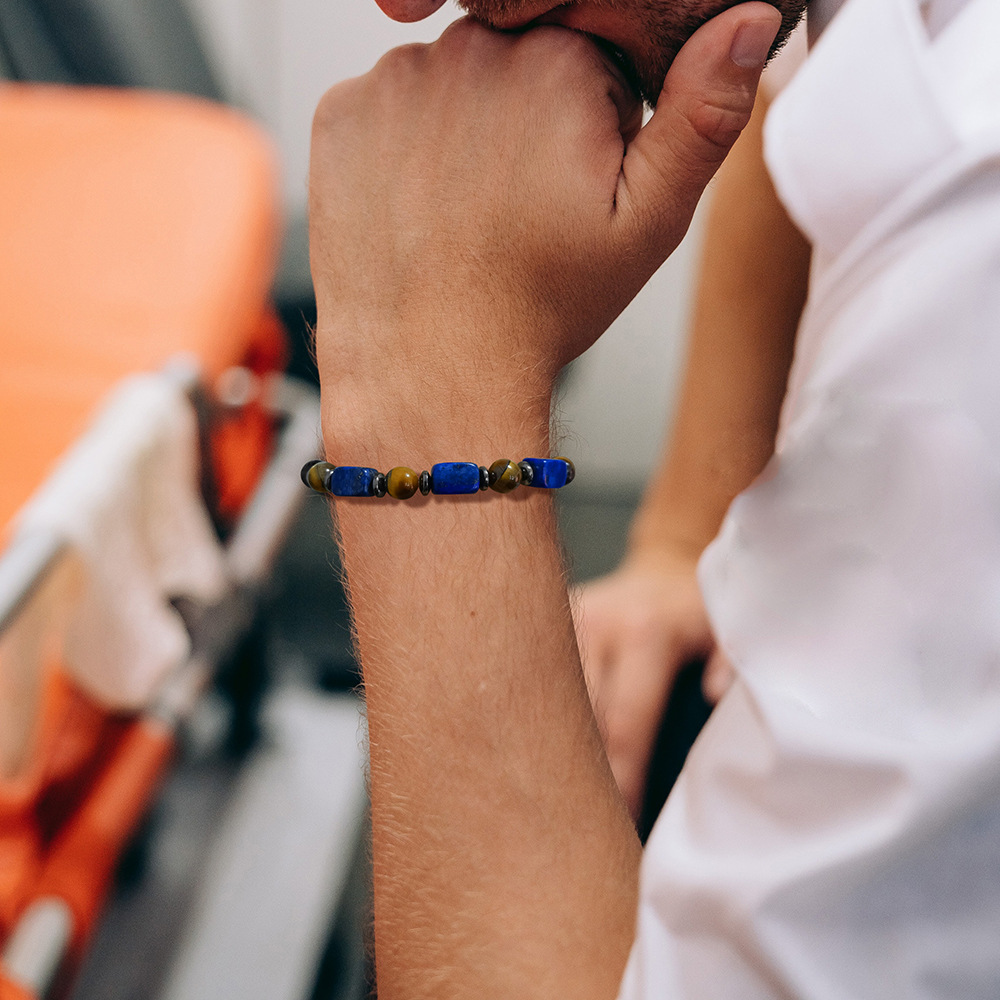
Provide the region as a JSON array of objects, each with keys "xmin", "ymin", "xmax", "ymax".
[{"xmin": 0, "ymin": 84, "xmax": 278, "ymax": 546}]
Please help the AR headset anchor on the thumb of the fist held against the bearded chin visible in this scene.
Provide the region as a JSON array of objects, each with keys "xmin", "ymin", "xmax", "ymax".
[{"xmin": 618, "ymin": 2, "xmax": 781, "ymax": 250}]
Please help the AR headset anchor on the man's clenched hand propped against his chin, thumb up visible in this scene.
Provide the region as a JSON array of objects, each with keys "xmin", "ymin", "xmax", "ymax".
[{"xmin": 310, "ymin": 3, "xmax": 779, "ymax": 434}]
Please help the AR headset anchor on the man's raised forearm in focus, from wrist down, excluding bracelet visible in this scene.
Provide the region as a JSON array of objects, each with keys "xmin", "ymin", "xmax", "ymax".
[{"xmin": 328, "ymin": 390, "xmax": 639, "ymax": 1000}]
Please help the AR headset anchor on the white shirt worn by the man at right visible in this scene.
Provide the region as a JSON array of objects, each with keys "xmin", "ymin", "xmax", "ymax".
[{"xmin": 621, "ymin": 0, "xmax": 1000, "ymax": 1000}]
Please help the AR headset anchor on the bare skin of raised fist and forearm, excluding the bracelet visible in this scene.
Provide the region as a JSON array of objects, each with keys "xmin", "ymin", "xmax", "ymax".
[{"xmin": 310, "ymin": 3, "xmax": 779, "ymax": 1000}]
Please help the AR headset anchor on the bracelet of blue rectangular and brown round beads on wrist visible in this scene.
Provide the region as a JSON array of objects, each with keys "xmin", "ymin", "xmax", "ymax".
[{"xmin": 302, "ymin": 458, "xmax": 576, "ymax": 500}]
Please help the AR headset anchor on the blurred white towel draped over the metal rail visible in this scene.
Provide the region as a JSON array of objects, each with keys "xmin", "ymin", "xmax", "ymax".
[{"xmin": 18, "ymin": 374, "xmax": 226, "ymax": 710}]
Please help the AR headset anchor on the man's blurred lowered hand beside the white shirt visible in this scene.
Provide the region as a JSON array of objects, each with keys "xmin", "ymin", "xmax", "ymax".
[{"xmin": 574, "ymin": 550, "xmax": 714, "ymax": 820}]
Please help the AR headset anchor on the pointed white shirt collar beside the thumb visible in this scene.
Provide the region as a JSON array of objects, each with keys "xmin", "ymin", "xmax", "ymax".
[{"xmin": 765, "ymin": 0, "xmax": 960, "ymax": 258}]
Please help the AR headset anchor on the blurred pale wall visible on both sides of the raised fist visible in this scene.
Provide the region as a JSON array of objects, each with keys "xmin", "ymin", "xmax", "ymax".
[{"xmin": 188, "ymin": 0, "xmax": 699, "ymax": 488}]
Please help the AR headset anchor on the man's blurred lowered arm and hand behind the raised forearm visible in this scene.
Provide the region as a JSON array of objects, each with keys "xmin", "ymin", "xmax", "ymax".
[{"xmin": 575, "ymin": 90, "xmax": 809, "ymax": 816}]
